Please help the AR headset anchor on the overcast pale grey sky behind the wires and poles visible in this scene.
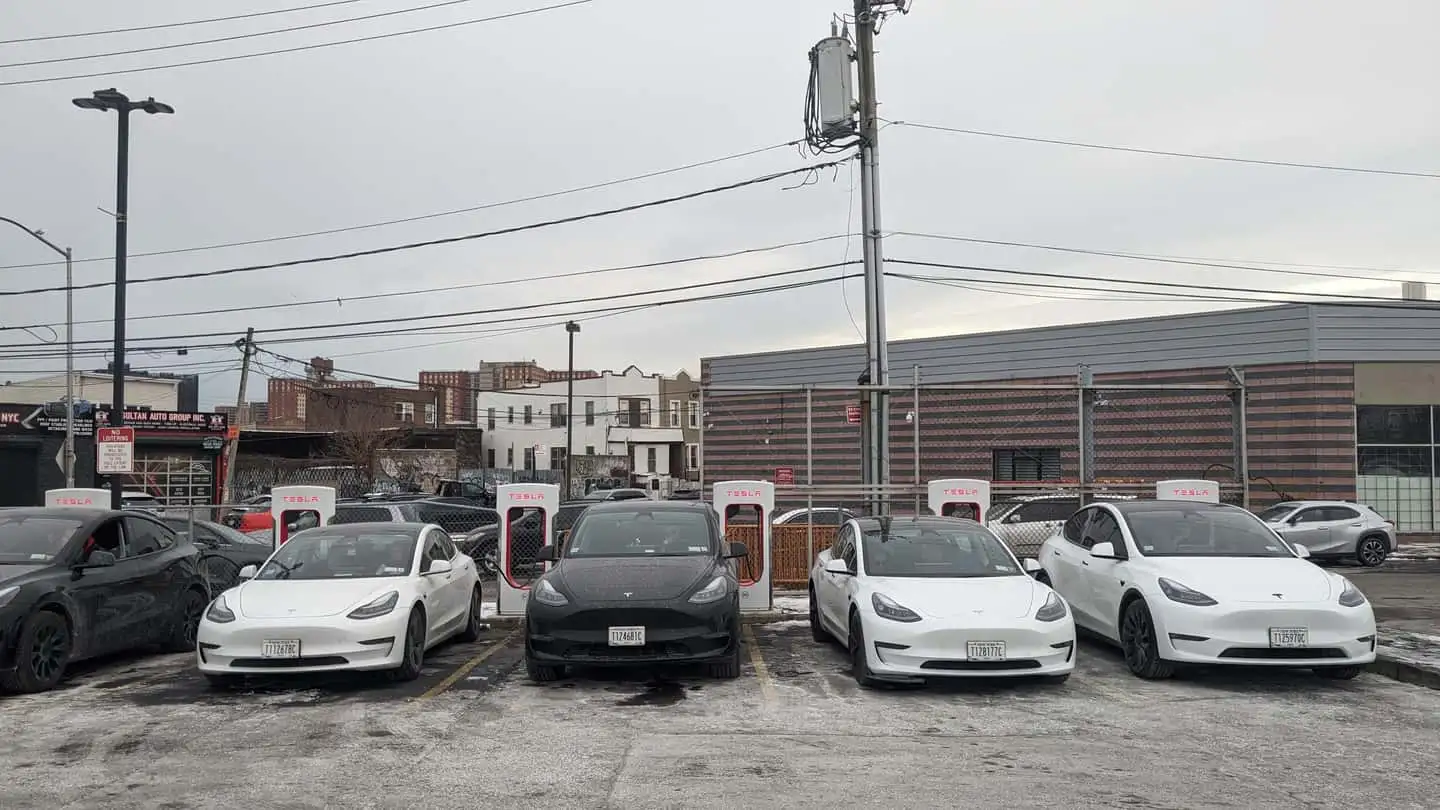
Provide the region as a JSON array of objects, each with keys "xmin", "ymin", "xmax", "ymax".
[{"xmin": 0, "ymin": 0, "xmax": 1440, "ymax": 406}]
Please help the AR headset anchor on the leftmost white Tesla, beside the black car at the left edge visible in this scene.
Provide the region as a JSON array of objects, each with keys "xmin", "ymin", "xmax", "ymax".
[{"xmin": 196, "ymin": 523, "xmax": 484, "ymax": 685}]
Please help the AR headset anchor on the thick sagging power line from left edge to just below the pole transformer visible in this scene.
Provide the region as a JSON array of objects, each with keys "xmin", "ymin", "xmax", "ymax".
[{"xmin": 0, "ymin": 159, "xmax": 850, "ymax": 297}]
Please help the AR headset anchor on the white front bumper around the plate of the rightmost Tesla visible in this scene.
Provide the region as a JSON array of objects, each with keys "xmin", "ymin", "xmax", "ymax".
[{"xmin": 1152, "ymin": 597, "xmax": 1378, "ymax": 667}]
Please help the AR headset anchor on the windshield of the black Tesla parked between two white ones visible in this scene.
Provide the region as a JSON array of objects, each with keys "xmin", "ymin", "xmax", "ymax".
[{"xmin": 566, "ymin": 509, "xmax": 716, "ymax": 558}]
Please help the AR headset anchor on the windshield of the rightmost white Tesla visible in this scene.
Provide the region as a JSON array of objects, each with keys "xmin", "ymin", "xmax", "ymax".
[{"xmin": 1126, "ymin": 506, "xmax": 1295, "ymax": 556}]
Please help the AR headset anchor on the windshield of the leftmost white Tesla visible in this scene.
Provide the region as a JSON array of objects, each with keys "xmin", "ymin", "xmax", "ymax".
[{"xmin": 255, "ymin": 530, "xmax": 415, "ymax": 579}]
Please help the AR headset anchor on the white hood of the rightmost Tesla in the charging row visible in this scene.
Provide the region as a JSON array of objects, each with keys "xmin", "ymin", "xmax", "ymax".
[{"xmin": 1152, "ymin": 556, "xmax": 1339, "ymax": 602}]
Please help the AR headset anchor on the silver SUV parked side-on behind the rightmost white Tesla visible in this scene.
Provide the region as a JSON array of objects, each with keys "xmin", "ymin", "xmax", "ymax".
[{"xmin": 1259, "ymin": 500, "xmax": 1398, "ymax": 568}]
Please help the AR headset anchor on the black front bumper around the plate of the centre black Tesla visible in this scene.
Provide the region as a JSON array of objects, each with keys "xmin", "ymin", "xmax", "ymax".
[{"xmin": 526, "ymin": 595, "xmax": 740, "ymax": 666}]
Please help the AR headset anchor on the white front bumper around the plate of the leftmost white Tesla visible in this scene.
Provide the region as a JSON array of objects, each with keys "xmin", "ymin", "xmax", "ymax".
[{"xmin": 196, "ymin": 611, "xmax": 408, "ymax": 675}]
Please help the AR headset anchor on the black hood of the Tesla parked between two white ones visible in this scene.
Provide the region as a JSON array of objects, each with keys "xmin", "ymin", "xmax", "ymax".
[{"xmin": 556, "ymin": 556, "xmax": 716, "ymax": 602}]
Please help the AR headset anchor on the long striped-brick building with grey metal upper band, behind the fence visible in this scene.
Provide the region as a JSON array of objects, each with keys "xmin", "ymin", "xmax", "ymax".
[{"xmin": 701, "ymin": 301, "xmax": 1440, "ymax": 532}]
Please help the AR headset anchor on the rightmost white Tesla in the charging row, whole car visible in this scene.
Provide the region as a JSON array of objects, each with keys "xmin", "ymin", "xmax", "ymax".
[{"xmin": 1040, "ymin": 500, "xmax": 1375, "ymax": 679}]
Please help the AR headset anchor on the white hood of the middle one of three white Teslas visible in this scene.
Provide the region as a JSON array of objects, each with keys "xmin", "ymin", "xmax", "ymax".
[{"xmin": 870, "ymin": 577, "xmax": 1045, "ymax": 620}]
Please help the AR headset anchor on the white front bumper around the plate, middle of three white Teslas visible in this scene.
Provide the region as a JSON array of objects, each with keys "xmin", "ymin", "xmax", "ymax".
[{"xmin": 861, "ymin": 615, "xmax": 1076, "ymax": 680}]
